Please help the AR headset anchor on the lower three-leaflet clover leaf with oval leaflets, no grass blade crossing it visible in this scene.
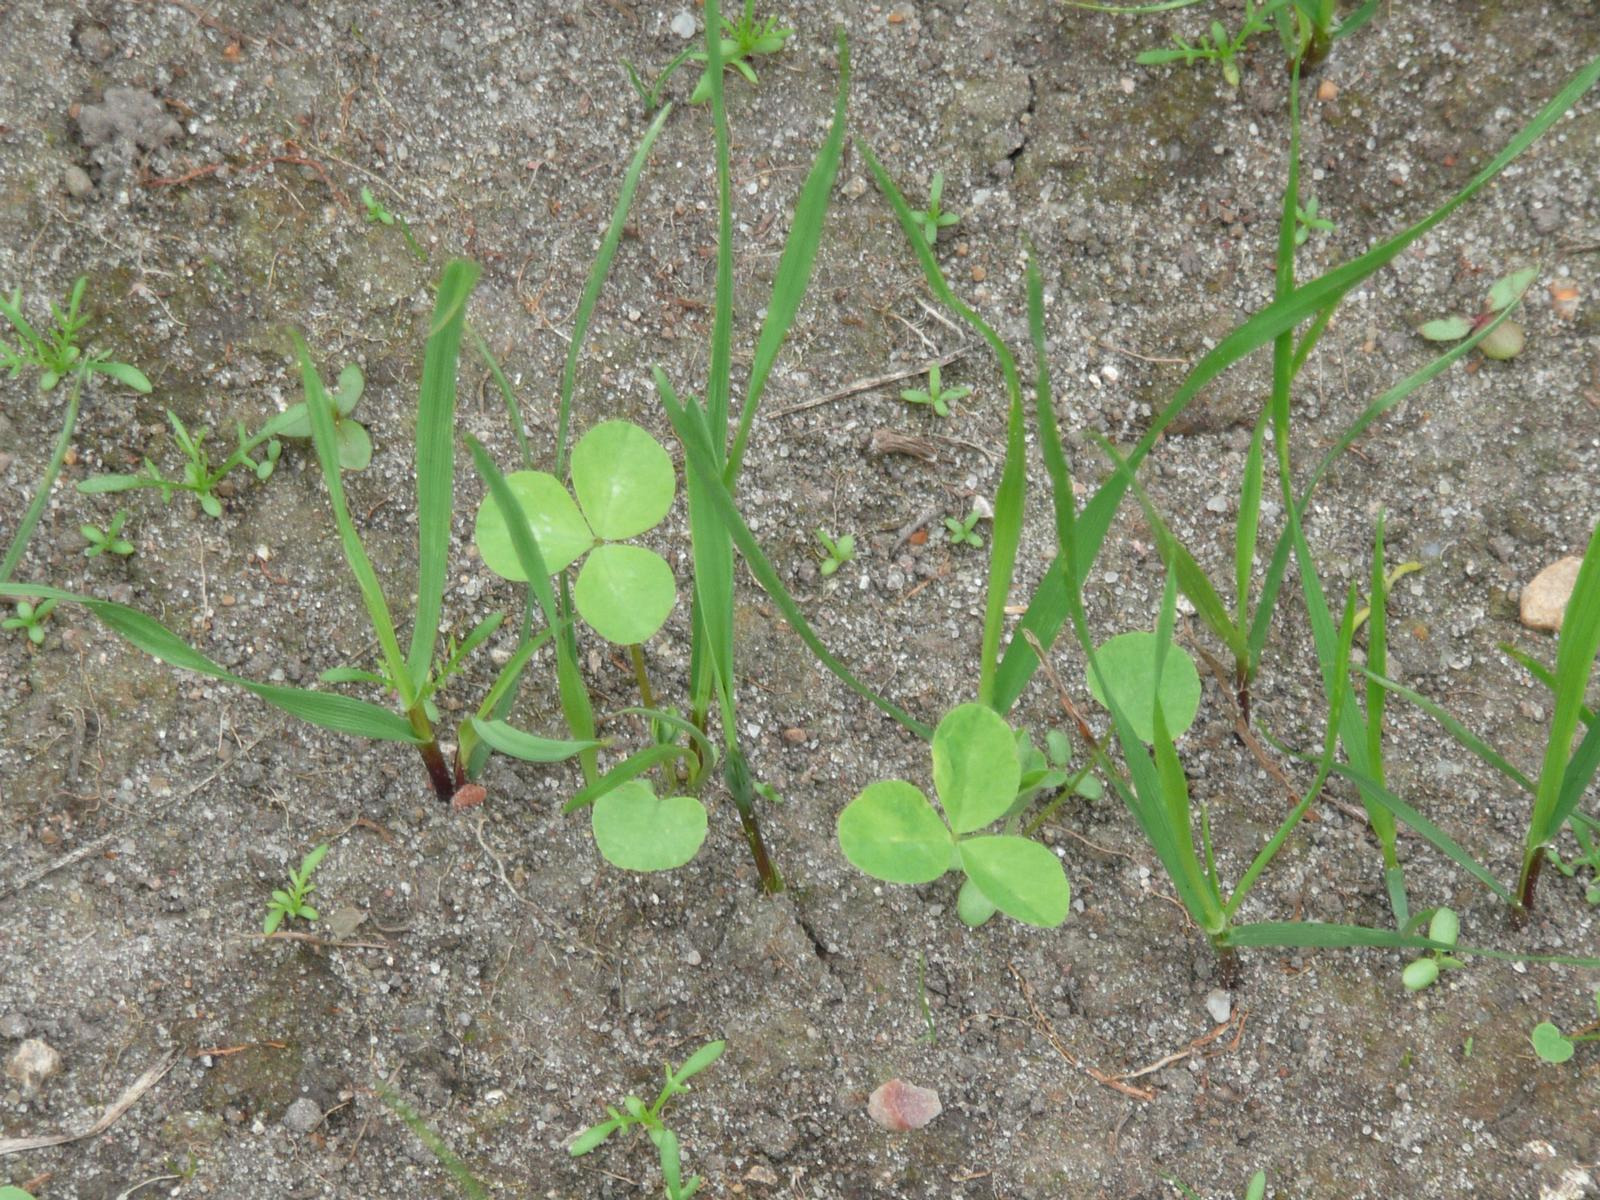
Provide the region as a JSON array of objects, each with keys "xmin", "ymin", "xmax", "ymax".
[{"xmin": 838, "ymin": 704, "xmax": 1070, "ymax": 928}]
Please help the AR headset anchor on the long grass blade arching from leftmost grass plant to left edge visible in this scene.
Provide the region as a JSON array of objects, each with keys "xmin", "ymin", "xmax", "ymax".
[{"xmin": 0, "ymin": 584, "xmax": 419, "ymax": 744}]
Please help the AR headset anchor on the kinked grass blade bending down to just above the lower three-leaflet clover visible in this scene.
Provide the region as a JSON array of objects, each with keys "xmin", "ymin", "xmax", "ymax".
[{"xmin": 856, "ymin": 141, "xmax": 1027, "ymax": 714}]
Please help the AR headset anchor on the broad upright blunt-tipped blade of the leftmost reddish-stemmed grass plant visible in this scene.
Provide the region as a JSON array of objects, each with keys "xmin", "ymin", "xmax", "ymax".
[{"xmin": 406, "ymin": 258, "xmax": 480, "ymax": 691}]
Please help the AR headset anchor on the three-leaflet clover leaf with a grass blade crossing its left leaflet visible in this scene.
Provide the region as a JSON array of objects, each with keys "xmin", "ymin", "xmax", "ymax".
[{"xmin": 474, "ymin": 421, "xmax": 678, "ymax": 645}]
